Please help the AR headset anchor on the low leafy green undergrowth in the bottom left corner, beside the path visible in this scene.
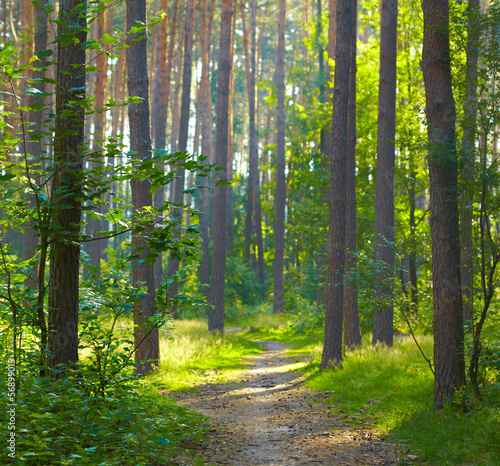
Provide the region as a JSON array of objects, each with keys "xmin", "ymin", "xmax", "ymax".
[{"xmin": 0, "ymin": 378, "xmax": 208, "ymax": 466}]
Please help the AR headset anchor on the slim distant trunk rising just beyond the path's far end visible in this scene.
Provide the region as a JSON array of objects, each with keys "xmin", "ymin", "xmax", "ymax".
[{"xmin": 273, "ymin": 0, "xmax": 286, "ymax": 314}]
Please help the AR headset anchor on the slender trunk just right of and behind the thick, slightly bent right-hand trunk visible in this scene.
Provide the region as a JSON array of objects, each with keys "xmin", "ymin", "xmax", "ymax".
[{"xmin": 460, "ymin": 0, "xmax": 481, "ymax": 327}]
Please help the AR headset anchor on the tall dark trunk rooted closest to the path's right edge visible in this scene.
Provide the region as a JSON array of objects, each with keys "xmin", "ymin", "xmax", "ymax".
[{"xmin": 320, "ymin": 0, "xmax": 353, "ymax": 369}]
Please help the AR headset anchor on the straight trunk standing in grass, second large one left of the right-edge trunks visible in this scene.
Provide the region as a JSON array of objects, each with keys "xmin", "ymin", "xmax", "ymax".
[{"xmin": 372, "ymin": 0, "xmax": 398, "ymax": 346}]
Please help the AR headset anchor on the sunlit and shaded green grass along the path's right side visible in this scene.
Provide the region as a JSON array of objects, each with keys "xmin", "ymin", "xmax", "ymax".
[{"xmin": 236, "ymin": 316, "xmax": 500, "ymax": 466}]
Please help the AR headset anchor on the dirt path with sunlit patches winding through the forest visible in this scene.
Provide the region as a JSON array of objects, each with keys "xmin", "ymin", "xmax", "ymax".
[{"xmin": 171, "ymin": 341, "xmax": 412, "ymax": 466}]
